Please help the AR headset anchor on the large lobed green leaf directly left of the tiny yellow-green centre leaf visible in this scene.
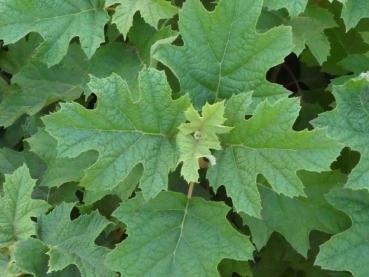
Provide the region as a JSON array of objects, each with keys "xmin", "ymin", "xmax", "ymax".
[{"xmin": 43, "ymin": 69, "xmax": 189, "ymax": 198}]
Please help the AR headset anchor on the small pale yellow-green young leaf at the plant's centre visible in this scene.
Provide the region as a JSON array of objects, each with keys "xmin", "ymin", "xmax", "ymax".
[{"xmin": 177, "ymin": 102, "xmax": 232, "ymax": 183}]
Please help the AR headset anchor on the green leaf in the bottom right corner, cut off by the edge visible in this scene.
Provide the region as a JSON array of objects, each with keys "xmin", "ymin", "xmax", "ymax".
[{"xmin": 315, "ymin": 190, "xmax": 369, "ymax": 277}]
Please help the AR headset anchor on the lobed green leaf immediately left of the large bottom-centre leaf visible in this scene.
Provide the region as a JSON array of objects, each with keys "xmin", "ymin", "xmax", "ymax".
[{"xmin": 38, "ymin": 203, "xmax": 114, "ymax": 277}]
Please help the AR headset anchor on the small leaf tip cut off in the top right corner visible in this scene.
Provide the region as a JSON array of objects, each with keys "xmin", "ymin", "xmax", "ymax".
[{"xmin": 331, "ymin": 0, "xmax": 369, "ymax": 30}]
